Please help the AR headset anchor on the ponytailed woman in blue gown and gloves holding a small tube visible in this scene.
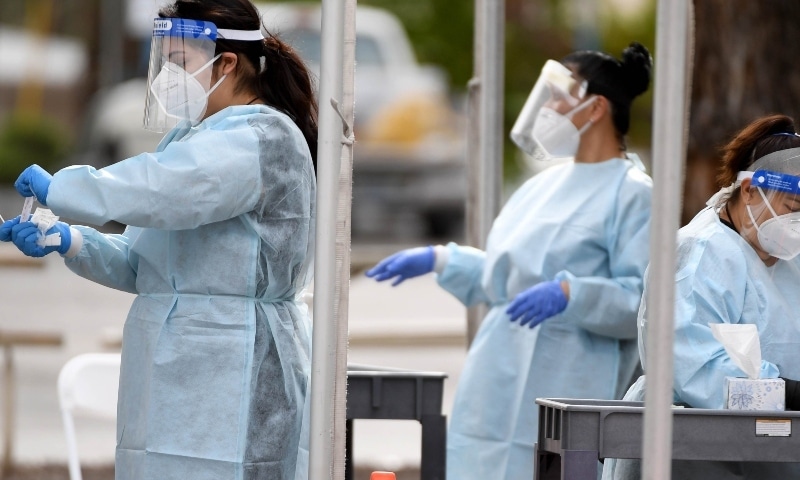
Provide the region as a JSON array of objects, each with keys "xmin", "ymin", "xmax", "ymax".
[{"xmin": 0, "ymin": 0, "xmax": 317, "ymax": 480}]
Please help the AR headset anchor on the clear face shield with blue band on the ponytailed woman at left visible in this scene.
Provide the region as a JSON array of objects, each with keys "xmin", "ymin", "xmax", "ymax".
[{"xmin": 144, "ymin": 18, "xmax": 264, "ymax": 132}]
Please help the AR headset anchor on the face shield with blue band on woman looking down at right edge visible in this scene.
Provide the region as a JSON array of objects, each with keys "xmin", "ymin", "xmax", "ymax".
[{"xmin": 739, "ymin": 148, "xmax": 800, "ymax": 260}]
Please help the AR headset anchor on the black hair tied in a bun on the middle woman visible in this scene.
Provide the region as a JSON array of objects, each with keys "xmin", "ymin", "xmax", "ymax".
[{"xmin": 561, "ymin": 42, "xmax": 653, "ymax": 145}]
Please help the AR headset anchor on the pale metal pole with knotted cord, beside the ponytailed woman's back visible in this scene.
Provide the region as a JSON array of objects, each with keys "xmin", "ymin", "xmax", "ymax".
[{"xmin": 308, "ymin": 0, "xmax": 345, "ymax": 480}]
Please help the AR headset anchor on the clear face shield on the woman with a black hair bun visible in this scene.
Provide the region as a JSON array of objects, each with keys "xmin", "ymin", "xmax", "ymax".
[{"xmin": 511, "ymin": 60, "xmax": 588, "ymax": 155}]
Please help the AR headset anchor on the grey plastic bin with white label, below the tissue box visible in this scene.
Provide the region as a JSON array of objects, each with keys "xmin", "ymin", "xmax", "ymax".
[{"xmin": 534, "ymin": 398, "xmax": 800, "ymax": 480}]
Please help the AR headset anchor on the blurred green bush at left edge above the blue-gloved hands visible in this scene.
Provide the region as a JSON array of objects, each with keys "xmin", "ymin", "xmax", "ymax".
[{"xmin": 0, "ymin": 113, "xmax": 69, "ymax": 183}]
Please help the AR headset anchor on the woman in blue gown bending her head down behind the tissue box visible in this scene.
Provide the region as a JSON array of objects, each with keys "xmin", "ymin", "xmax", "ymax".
[{"xmin": 603, "ymin": 115, "xmax": 800, "ymax": 480}]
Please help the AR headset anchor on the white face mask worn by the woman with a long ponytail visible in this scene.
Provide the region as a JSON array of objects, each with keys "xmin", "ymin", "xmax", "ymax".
[{"xmin": 150, "ymin": 55, "xmax": 227, "ymax": 123}]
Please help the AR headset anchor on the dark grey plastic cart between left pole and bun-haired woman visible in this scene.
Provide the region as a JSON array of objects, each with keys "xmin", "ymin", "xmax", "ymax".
[{"xmin": 345, "ymin": 365, "xmax": 447, "ymax": 480}]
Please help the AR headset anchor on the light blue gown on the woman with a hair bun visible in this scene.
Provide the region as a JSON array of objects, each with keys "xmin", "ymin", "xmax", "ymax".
[{"xmin": 437, "ymin": 159, "xmax": 652, "ymax": 480}]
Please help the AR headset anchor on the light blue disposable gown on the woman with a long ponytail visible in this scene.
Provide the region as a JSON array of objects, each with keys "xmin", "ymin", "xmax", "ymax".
[{"xmin": 47, "ymin": 105, "xmax": 316, "ymax": 480}]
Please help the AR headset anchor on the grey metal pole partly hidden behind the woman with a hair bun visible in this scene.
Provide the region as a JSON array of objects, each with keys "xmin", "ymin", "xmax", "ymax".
[{"xmin": 467, "ymin": 0, "xmax": 505, "ymax": 344}]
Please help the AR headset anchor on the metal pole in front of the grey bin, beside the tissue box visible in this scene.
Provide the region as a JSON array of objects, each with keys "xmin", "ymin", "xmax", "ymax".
[{"xmin": 642, "ymin": 0, "xmax": 690, "ymax": 480}]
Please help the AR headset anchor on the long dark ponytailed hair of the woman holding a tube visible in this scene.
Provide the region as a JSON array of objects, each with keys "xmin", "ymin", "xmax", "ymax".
[{"xmin": 158, "ymin": 0, "xmax": 318, "ymax": 171}]
